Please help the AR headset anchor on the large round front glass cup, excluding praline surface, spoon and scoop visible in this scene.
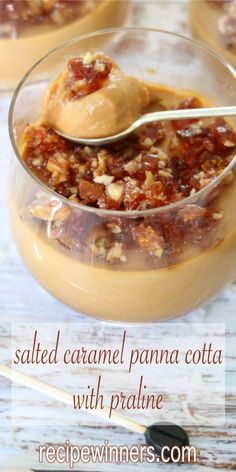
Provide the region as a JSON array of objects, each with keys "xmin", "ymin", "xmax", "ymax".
[{"xmin": 9, "ymin": 29, "xmax": 236, "ymax": 323}]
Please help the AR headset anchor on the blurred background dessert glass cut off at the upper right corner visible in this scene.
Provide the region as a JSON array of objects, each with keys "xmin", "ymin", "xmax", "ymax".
[{"xmin": 189, "ymin": 0, "xmax": 236, "ymax": 67}]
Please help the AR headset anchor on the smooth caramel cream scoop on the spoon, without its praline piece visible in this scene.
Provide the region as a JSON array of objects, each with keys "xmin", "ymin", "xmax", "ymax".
[{"xmin": 42, "ymin": 54, "xmax": 150, "ymax": 138}]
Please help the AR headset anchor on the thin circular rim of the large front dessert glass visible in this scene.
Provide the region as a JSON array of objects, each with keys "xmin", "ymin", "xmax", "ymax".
[{"xmin": 8, "ymin": 27, "xmax": 236, "ymax": 217}]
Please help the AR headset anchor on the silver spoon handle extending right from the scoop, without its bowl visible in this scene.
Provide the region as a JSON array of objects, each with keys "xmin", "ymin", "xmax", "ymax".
[{"xmin": 134, "ymin": 106, "xmax": 236, "ymax": 129}]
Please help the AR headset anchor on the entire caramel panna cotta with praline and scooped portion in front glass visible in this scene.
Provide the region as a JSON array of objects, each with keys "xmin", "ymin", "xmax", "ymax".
[{"xmin": 10, "ymin": 31, "xmax": 236, "ymax": 322}]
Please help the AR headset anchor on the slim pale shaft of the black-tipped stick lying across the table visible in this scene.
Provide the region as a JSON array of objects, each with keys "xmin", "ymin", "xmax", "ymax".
[{"xmin": 0, "ymin": 364, "xmax": 147, "ymax": 434}]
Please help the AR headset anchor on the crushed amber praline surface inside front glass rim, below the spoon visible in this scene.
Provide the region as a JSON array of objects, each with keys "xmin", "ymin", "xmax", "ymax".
[{"xmin": 23, "ymin": 111, "xmax": 236, "ymax": 211}]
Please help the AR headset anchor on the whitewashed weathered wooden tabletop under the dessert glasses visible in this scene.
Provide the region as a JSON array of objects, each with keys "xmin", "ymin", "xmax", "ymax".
[{"xmin": 0, "ymin": 0, "xmax": 236, "ymax": 472}]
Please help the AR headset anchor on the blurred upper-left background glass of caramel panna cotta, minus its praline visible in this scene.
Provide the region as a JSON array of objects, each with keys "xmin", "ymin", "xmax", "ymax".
[{"xmin": 0, "ymin": 0, "xmax": 129, "ymax": 90}]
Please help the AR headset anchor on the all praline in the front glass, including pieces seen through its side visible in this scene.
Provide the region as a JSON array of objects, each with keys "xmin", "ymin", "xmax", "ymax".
[{"xmin": 23, "ymin": 97, "xmax": 236, "ymax": 267}]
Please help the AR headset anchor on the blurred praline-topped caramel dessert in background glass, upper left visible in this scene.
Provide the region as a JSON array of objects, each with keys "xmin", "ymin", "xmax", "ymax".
[{"xmin": 0, "ymin": 0, "xmax": 129, "ymax": 89}]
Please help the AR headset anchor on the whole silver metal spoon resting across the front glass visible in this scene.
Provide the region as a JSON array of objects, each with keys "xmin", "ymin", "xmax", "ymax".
[{"xmin": 55, "ymin": 106, "xmax": 236, "ymax": 146}]
